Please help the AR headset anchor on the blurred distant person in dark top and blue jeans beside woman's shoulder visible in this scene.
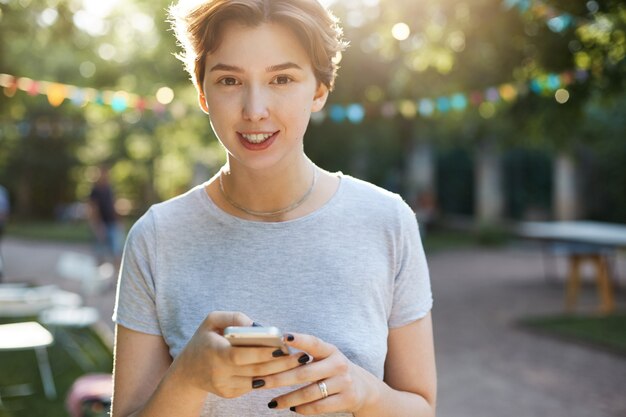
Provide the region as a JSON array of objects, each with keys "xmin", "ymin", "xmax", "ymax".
[{"xmin": 87, "ymin": 165, "xmax": 124, "ymax": 270}]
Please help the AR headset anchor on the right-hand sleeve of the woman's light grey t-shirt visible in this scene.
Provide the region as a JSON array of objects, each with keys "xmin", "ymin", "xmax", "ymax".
[{"xmin": 389, "ymin": 201, "xmax": 433, "ymax": 328}]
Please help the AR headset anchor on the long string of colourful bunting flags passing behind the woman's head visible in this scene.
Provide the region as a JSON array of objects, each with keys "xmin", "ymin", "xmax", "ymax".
[{"xmin": 0, "ymin": 70, "xmax": 588, "ymax": 124}]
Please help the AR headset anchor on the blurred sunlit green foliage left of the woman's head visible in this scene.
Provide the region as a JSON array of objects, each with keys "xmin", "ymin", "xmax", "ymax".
[{"xmin": 0, "ymin": 0, "xmax": 220, "ymax": 217}]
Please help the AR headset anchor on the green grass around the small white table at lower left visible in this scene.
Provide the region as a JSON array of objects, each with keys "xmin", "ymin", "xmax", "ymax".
[{"xmin": 0, "ymin": 320, "xmax": 113, "ymax": 417}]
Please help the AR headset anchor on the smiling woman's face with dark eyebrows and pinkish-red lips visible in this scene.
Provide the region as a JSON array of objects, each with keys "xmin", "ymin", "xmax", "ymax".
[{"xmin": 200, "ymin": 23, "xmax": 328, "ymax": 169}]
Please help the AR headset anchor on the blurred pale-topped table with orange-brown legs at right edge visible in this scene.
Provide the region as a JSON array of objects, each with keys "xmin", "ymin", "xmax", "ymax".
[{"xmin": 517, "ymin": 221, "xmax": 626, "ymax": 313}]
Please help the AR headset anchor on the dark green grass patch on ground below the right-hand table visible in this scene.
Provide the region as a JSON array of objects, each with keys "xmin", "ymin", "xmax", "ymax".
[{"xmin": 520, "ymin": 313, "xmax": 626, "ymax": 355}]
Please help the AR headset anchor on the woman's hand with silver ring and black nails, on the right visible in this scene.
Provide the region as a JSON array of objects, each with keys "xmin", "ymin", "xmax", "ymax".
[{"xmin": 263, "ymin": 333, "xmax": 379, "ymax": 415}]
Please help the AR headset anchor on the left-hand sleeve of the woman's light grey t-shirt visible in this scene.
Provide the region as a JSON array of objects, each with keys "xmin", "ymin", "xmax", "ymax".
[{"xmin": 113, "ymin": 211, "xmax": 161, "ymax": 335}]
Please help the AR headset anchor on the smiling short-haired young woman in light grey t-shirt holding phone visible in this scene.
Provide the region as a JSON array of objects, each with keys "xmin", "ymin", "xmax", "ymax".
[{"xmin": 113, "ymin": 0, "xmax": 436, "ymax": 417}]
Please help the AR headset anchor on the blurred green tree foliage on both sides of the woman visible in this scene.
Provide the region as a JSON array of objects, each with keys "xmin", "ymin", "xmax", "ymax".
[{"xmin": 0, "ymin": 0, "xmax": 626, "ymax": 217}]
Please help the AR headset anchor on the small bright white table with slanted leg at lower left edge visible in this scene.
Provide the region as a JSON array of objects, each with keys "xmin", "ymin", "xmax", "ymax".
[{"xmin": 0, "ymin": 321, "xmax": 57, "ymax": 400}]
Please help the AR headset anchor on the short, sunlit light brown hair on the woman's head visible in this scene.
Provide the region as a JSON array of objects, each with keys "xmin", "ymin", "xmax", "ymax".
[{"xmin": 168, "ymin": 0, "xmax": 348, "ymax": 90}]
